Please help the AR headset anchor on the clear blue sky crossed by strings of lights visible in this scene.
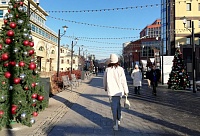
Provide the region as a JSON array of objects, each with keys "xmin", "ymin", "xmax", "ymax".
[{"xmin": 40, "ymin": 0, "xmax": 161, "ymax": 59}]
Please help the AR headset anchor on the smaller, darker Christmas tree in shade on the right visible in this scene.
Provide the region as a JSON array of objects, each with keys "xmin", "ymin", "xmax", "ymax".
[{"xmin": 167, "ymin": 47, "xmax": 190, "ymax": 90}]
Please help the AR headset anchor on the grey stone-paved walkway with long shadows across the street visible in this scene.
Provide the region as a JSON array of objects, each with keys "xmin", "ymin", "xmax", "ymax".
[{"xmin": 0, "ymin": 74, "xmax": 200, "ymax": 136}]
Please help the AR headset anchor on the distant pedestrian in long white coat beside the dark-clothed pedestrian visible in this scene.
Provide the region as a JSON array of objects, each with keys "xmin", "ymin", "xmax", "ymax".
[{"xmin": 131, "ymin": 64, "xmax": 142, "ymax": 95}]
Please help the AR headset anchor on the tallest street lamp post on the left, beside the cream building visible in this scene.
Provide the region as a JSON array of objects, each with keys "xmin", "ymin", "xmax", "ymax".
[{"xmin": 57, "ymin": 26, "xmax": 68, "ymax": 77}]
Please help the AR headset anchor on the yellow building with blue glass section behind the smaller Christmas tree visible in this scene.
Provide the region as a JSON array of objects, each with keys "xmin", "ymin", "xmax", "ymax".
[{"xmin": 161, "ymin": 0, "xmax": 200, "ymax": 79}]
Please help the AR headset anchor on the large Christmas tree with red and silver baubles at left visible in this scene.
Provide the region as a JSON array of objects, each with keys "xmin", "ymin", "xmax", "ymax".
[{"xmin": 0, "ymin": 0, "xmax": 47, "ymax": 128}]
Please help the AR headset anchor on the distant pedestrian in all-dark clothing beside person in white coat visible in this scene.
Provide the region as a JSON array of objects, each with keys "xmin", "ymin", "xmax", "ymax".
[{"xmin": 149, "ymin": 65, "xmax": 160, "ymax": 96}]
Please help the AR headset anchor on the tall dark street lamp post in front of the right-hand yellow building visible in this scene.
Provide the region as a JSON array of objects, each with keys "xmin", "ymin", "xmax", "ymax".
[{"xmin": 183, "ymin": 16, "xmax": 196, "ymax": 93}]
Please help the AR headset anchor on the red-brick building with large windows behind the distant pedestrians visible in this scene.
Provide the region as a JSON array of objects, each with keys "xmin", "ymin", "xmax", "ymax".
[{"xmin": 123, "ymin": 19, "xmax": 162, "ymax": 70}]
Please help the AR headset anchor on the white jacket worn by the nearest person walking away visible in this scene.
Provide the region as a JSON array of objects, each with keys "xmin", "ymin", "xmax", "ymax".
[{"xmin": 103, "ymin": 66, "xmax": 129, "ymax": 96}]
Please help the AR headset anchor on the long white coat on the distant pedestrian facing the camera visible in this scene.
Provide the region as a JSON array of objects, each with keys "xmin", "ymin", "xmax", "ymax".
[{"xmin": 131, "ymin": 69, "xmax": 142, "ymax": 86}]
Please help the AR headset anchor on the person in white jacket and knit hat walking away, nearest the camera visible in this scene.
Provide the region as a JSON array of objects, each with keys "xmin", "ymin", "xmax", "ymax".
[{"xmin": 103, "ymin": 54, "xmax": 129, "ymax": 130}]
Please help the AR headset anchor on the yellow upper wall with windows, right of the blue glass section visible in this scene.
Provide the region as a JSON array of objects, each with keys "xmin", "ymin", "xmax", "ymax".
[{"xmin": 174, "ymin": 0, "xmax": 200, "ymax": 47}]
